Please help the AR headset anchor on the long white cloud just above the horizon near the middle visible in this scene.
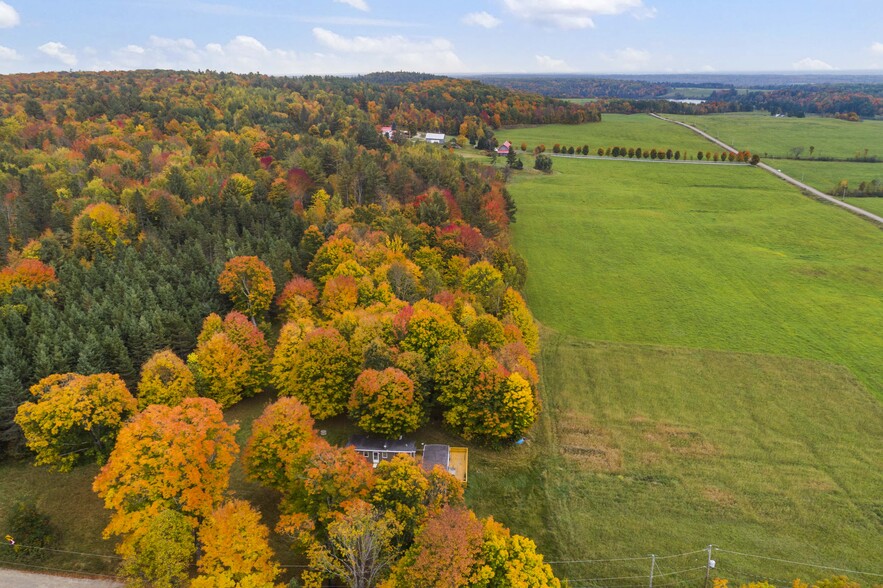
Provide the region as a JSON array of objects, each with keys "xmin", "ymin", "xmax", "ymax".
[{"xmin": 313, "ymin": 27, "xmax": 463, "ymax": 72}]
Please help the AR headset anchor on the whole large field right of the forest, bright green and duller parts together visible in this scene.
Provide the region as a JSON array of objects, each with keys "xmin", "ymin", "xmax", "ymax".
[{"xmin": 480, "ymin": 139, "xmax": 883, "ymax": 586}]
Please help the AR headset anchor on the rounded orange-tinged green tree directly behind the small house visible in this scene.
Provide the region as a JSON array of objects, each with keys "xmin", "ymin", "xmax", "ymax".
[{"xmin": 349, "ymin": 368, "xmax": 423, "ymax": 439}]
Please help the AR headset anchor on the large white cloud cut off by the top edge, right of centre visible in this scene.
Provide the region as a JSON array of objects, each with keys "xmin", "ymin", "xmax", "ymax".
[{"xmin": 503, "ymin": 0, "xmax": 656, "ymax": 29}]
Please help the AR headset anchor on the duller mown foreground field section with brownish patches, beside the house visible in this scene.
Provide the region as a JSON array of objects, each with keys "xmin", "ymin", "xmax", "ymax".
[{"xmin": 468, "ymin": 332, "xmax": 883, "ymax": 586}]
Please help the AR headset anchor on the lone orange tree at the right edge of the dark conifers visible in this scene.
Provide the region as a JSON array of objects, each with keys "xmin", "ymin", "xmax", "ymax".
[{"xmin": 218, "ymin": 255, "xmax": 276, "ymax": 321}]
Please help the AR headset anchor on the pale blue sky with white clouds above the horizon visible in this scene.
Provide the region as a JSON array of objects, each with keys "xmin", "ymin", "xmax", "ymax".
[{"xmin": 0, "ymin": 0, "xmax": 883, "ymax": 75}]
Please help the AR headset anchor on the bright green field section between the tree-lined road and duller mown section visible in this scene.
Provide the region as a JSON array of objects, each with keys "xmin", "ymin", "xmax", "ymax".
[{"xmin": 510, "ymin": 158, "xmax": 883, "ymax": 398}]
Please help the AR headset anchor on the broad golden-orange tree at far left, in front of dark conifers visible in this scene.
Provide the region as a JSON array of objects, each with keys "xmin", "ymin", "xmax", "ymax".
[{"xmin": 15, "ymin": 374, "xmax": 137, "ymax": 472}]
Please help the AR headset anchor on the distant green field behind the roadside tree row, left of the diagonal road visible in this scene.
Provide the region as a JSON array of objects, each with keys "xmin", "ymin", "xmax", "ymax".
[{"xmin": 497, "ymin": 114, "xmax": 720, "ymax": 157}]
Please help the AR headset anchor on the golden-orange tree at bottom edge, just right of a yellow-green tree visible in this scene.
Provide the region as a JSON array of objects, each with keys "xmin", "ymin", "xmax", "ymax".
[{"xmin": 190, "ymin": 500, "xmax": 282, "ymax": 588}]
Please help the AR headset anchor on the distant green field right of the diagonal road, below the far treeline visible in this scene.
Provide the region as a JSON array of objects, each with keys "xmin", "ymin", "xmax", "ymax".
[{"xmin": 670, "ymin": 112, "xmax": 883, "ymax": 159}]
